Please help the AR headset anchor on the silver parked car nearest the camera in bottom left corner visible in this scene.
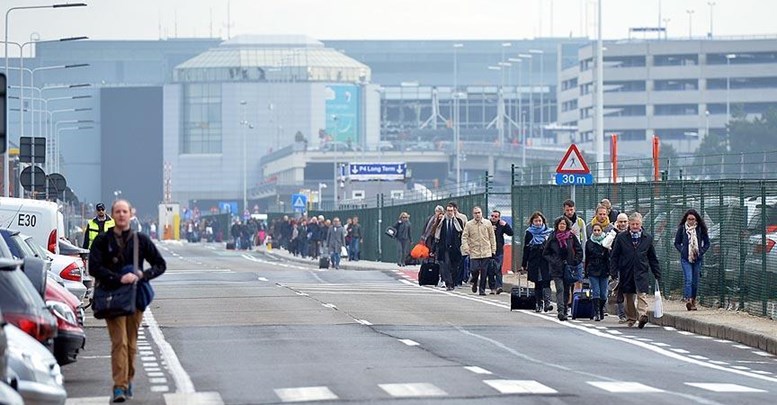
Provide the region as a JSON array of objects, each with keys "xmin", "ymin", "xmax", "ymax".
[{"xmin": 0, "ymin": 318, "xmax": 67, "ymax": 405}]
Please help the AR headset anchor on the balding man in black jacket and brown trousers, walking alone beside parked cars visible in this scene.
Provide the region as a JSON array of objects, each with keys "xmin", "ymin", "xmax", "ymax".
[{"xmin": 89, "ymin": 200, "xmax": 167, "ymax": 402}]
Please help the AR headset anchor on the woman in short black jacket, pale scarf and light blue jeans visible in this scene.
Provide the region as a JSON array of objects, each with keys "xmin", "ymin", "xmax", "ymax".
[{"xmin": 585, "ymin": 224, "xmax": 610, "ymax": 321}]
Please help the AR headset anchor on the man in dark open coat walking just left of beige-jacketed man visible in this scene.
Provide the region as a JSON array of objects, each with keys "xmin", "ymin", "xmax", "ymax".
[{"xmin": 435, "ymin": 203, "xmax": 465, "ymax": 291}]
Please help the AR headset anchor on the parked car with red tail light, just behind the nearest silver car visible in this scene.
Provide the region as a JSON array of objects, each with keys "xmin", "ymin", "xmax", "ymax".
[{"xmin": 0, "ymin": 258, "xmax": 57, "ymax": 347}]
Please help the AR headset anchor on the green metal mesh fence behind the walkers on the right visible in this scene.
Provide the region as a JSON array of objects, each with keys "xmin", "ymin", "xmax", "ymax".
[{"xmin": 512, "ymin": 180, "xmax": 777, "ymax": 319}]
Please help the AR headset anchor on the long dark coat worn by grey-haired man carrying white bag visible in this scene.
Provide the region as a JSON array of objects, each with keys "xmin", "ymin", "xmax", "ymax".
[{"xmin": 610, "ymin": 230, "xmax": 661, "ymax": 294}]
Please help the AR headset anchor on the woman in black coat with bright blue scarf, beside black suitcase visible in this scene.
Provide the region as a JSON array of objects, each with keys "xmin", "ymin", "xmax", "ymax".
[{"xmin": 521, "ymin": 211, "xmax": 553, "ymax": 312}]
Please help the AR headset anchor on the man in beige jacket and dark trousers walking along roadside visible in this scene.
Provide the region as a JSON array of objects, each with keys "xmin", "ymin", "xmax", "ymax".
[{"xmin": 461, "ymin": 206, "xmax": 496, "ymax": 295}]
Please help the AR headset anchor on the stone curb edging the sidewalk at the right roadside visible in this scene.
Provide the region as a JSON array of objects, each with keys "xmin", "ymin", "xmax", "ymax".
[{"xmin": 502, "ymin": 282, "xmax": 777, "ymax": 355}]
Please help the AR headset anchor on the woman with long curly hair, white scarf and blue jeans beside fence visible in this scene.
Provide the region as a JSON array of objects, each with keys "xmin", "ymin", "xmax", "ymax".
[{"xmin": 674, "ymin": 209, "xmax": 710, "ymax": 311}]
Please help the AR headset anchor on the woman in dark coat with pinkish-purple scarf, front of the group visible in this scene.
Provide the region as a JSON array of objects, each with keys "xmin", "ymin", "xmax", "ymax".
[{"xmin": 542, "ymin": 216, "xmax": 583, "ymax": 321}]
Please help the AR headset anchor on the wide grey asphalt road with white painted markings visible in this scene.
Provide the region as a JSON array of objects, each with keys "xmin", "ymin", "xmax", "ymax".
[{"xmin": 64, "ymin": 244, "xmax": 777, "ymax": 404}]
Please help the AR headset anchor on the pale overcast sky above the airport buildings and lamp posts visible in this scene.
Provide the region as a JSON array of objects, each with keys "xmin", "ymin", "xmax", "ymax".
[{"xmin": 0, "ymin": 0, "xmax": 777, "ymax": 53}]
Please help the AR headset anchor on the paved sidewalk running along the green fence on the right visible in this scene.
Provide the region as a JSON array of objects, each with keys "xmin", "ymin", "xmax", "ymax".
[{"xmin": 259, "ymin": 246, "xmax": 777, "ymax": 355}]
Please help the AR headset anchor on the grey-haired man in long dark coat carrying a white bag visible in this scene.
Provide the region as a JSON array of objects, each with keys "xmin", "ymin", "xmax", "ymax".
[{"xmin": 610, "ymin": 212, "xmax": 661, "ymax": 329}]
